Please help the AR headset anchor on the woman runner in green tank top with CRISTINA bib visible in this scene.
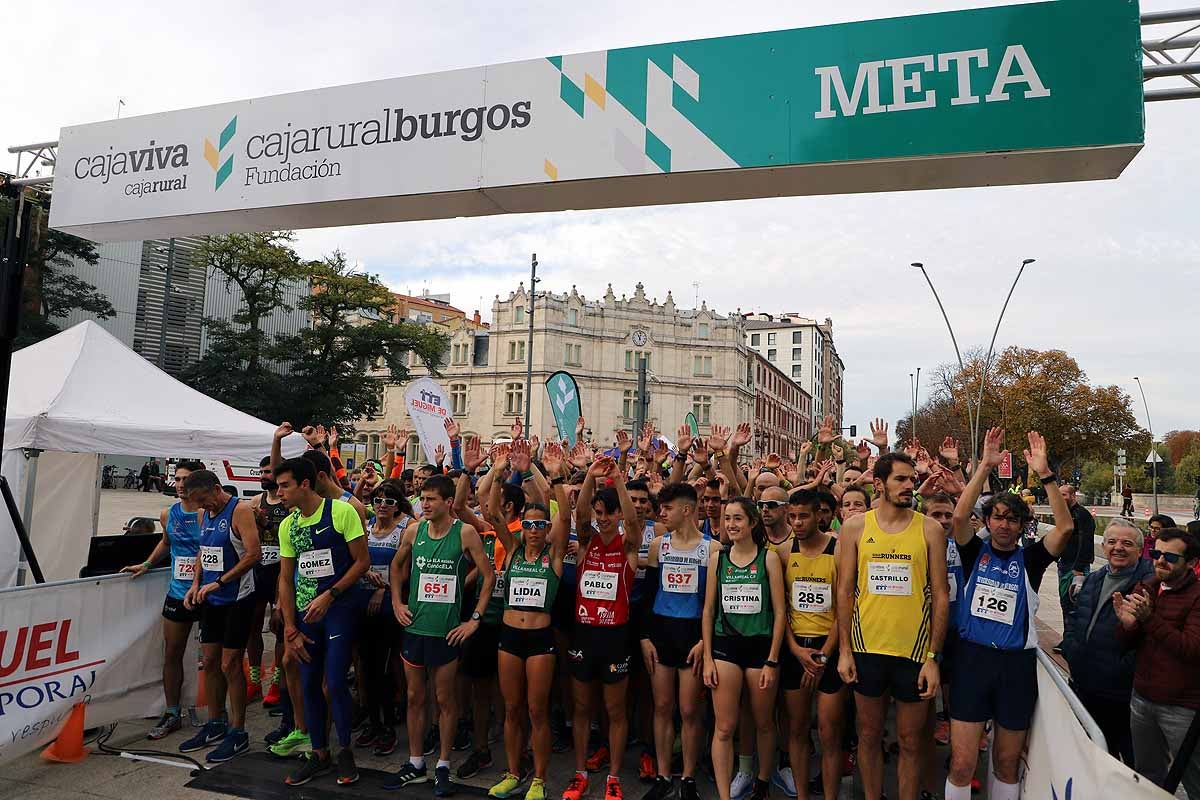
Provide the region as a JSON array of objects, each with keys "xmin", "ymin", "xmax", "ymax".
[{"xmin": 703, "ymin": 498, "xmax": 787, "ymax": 800}]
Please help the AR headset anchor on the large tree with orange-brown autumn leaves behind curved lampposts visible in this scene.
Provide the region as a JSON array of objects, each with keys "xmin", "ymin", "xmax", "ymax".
[{"xmin": 896, "ymin": 347, "xmax": 1150, "ymax": 475}]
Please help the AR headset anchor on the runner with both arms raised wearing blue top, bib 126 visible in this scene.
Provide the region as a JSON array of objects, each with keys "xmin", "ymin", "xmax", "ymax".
[{"xmin": 946, "ymin": 428, "xmax": 1074, "ymax": 800}]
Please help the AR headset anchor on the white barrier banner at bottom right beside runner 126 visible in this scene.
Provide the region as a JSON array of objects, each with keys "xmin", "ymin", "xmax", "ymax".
[{"xmin": 1021, "ymin": 661, "xmax": 1171, "ymax": 800}]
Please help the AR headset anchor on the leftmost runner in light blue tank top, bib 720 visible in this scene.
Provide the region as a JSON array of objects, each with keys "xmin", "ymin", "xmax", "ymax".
[{"xmin": 121, "ymin": 461, "xmax": 204, "ymax": 739}]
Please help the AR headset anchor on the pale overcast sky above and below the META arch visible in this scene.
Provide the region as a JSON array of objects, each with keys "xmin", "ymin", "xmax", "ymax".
[{"xmin": 0, "ymin": 0, "xmax": 1200, "ymax": 435}]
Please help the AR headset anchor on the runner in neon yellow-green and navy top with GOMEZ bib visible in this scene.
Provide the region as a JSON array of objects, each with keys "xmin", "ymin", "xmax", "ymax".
[{"xmin": 275, "ymin": 458, "xmax": 371, "ymax": 786}]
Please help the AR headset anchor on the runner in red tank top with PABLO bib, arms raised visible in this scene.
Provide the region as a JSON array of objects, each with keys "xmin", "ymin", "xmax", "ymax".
[{"xmin": 563, "ymin": 457, "xmax": 642, "ymax": 800}]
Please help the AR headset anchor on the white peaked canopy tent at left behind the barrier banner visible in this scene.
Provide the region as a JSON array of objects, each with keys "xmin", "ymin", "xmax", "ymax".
[{"xmin": 0, "ymin": 321, "xmax": 304, "ymax": 587}]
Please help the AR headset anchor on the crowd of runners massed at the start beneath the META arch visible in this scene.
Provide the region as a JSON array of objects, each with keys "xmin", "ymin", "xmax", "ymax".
[{"xmin": 119, "ymin": 419, "xmax": 1200, "ymax": 800}]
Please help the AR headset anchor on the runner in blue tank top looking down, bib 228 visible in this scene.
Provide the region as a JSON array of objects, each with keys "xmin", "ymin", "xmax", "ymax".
[{"xmin": 179, "ymin": 469, "xmax": 262, "ymax": 763}]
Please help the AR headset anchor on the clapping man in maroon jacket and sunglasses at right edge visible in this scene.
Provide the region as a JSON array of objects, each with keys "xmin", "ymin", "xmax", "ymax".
[{"xmin": 1112, "ymin": 528, "xmax": 1200, "ymax": 800}]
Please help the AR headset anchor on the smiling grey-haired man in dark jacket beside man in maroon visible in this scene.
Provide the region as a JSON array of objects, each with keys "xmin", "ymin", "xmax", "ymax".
[{"xmin": 1062, "ymin": 517, "xmax": 1154, "ymax": 765}]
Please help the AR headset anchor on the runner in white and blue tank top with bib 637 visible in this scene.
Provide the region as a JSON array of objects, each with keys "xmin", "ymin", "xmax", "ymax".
[{"xmin": 641, "ymin": 483, "xmax": 721, "ymax": 800}]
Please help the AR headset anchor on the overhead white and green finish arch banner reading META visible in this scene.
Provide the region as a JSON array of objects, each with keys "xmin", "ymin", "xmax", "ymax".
[{"xmin": 50, "ymin": 0, "xmax": 1144, "ymax": 241}]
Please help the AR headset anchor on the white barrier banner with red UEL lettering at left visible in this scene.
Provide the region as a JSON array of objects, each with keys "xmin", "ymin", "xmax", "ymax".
[{"xmin": 0, "ymin": 570, "xmax": 178, "ymax": 764}]
